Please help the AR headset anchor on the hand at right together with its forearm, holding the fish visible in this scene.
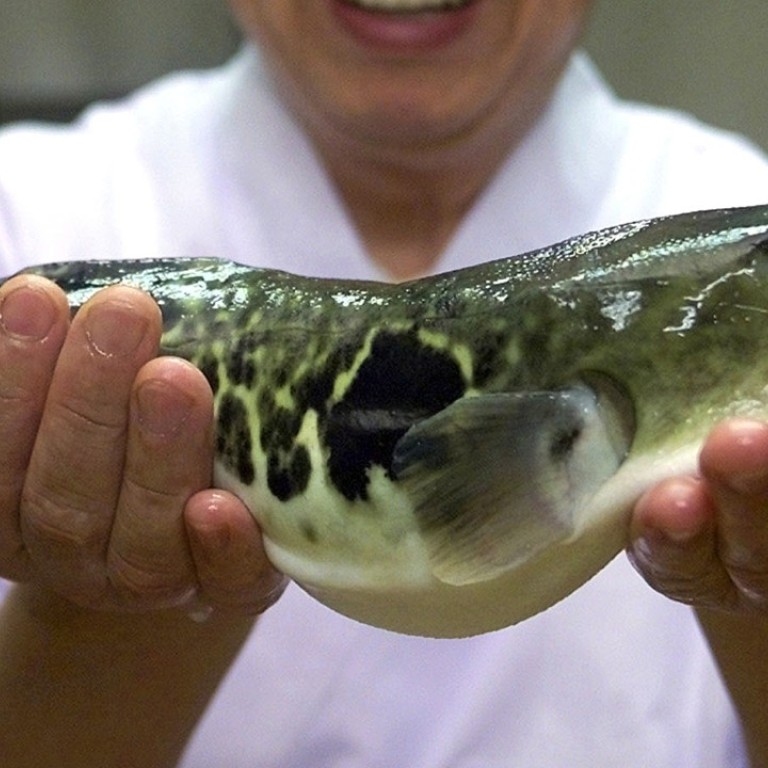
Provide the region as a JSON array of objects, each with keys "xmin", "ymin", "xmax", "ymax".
[{"xmin": 629, "ymin": 419, "xmax": 768, "ymax": 767}]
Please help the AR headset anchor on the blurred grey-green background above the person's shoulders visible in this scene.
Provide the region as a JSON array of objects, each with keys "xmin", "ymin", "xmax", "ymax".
[{"xmin": 0, "ymin": 0, "xmax": 768, "ymax": 149}]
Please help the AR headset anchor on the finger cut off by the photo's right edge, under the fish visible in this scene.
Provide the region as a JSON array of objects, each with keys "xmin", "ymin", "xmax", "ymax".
[{"xmin": 701, "ymin": 419, "xmax": 768, "ymax": 608}]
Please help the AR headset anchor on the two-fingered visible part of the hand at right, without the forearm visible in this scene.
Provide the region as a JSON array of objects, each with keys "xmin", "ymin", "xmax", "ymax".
[{"xmin": 628, "ymin": 419, "xmax": 768, "ymax": 616}]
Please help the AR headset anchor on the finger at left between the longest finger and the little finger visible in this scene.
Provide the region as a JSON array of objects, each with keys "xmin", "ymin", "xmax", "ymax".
[{"xmin": 107, "ymin": 358, "xmax": 213, "ymax": 608}]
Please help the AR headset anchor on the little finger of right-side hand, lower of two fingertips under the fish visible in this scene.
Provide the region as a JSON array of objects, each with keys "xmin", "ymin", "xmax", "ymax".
[{"xmin": 628, "ymin": 477, "xmax": 738, "ymax": 609}]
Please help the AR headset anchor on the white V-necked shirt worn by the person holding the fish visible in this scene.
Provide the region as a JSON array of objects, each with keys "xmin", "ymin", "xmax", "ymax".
[{"xmin": 0, "ymin": 45, "xmax": 768, "ymax": 768}]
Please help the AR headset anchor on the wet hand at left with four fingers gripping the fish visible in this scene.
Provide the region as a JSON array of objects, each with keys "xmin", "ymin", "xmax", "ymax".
[{"xmin": 0, "ymin": 276, "xmax": 285, "ymax": 613}]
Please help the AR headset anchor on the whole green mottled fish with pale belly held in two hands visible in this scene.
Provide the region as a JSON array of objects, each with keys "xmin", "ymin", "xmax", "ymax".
[{"xmin": 12, "ymin": 206, "xmax": 768, "ymax": 637}]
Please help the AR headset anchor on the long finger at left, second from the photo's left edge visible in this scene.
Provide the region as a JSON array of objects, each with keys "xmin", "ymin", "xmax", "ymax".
[{"xmin": 21, "ymin": 286, "xmax": 161, "ymax": 604}]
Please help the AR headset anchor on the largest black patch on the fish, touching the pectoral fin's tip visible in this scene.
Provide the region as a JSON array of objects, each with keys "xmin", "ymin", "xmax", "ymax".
[{"xmin": 325, "ymin": 331, "xmax": 466, "ymax": 500}]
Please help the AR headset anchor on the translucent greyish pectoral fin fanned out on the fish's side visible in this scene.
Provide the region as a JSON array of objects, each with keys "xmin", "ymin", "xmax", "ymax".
[{"xmin": 392, "ymin": 385, "xmax": 626, "ymax": 585}]
